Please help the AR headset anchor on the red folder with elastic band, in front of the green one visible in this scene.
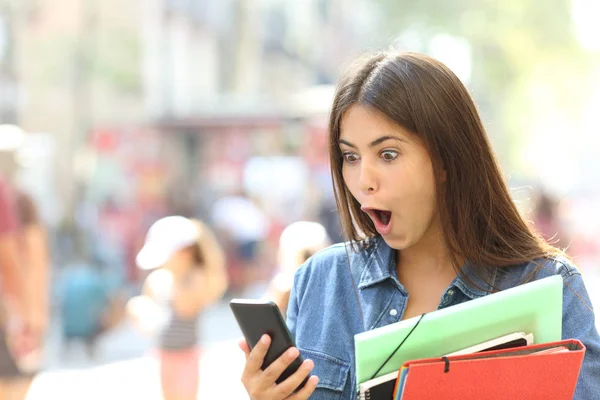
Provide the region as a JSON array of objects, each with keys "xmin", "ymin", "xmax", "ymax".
[{"xmin": 402, "ymin": 339, "xmax": 585, "ymax": 400}]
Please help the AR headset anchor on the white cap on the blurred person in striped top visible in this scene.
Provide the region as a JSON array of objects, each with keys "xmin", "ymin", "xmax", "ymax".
[{"xmin": 135, "ymin": 216, "xmax": 200, "ymax": 269}]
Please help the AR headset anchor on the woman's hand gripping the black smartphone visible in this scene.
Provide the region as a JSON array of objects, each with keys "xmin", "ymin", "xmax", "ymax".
[{"xmin": 239, "ymin": 335, "xmax": 319, "ymax": 400}]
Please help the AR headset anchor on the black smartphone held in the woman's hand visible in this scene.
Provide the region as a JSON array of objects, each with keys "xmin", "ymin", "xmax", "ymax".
[{"xmin": 229, "ymin": 299, "xmax": 308, "ymax": 390}]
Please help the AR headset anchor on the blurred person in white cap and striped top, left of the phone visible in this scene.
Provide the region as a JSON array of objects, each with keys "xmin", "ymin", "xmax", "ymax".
[{"xmin": 127, "ymin": 216, "xmax": 227, "ymax": 400}]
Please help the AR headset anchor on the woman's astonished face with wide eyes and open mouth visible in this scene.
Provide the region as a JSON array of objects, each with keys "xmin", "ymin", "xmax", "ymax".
[{"xmin": 339, "ymin": 105, "xmax": 439, "ymax": 250}]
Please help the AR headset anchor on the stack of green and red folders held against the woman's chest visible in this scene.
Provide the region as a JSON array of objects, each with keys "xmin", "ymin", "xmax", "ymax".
[{"xmin": 355, "ymin": 276, "xmax": 585, "ymax": 400}]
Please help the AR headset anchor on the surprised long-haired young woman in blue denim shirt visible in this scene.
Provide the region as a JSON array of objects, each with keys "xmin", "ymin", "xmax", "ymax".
[{"xmin": 240, "ymin": 52, "xmax": 600, "ymax": 400}]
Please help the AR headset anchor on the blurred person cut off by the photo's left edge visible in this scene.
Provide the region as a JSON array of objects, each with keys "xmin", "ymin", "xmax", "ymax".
[{"xmin": 0, "ymin": 126, "xmax": 49, "ymax": 400}]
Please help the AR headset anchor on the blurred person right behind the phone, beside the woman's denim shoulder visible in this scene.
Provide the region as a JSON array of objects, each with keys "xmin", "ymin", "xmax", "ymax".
[{"xmin": 264, "ymin": 221, "xmax": 330, "ymax": 318}]
